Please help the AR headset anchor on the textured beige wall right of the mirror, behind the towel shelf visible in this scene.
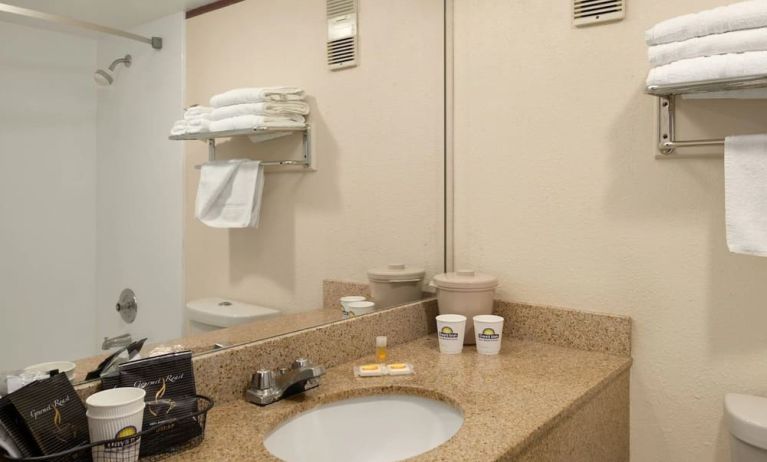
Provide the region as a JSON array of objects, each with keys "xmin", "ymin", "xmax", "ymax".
[{"xmin": 455, "ymin": 0, "xmax": 767, "ymax": 462}]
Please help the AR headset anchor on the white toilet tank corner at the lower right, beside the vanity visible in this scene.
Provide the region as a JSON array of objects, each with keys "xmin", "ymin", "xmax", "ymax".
[{"xmin": 724, "ymin": 393, "xmax": 767, "ymax": 462}]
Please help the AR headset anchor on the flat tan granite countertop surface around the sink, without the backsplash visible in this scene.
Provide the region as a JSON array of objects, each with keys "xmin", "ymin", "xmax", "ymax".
[{"xmin": 162, "ymin": 335, "xmax": 631, "ymax": 461}]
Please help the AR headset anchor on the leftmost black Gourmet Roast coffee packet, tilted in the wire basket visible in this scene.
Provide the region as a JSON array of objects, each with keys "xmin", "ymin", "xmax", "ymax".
[{"xmin": 8, "ymin": 374, "xmax": 89, "ymax": 460}]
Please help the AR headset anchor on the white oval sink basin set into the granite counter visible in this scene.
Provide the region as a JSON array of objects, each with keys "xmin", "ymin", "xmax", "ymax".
[{"xmin": 264, "ymin": 395, "xmax": 463, "ymax": 462}]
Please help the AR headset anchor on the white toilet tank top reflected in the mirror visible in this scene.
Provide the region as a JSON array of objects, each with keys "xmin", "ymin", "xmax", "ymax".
[{"xmin": 184, "ymin": 297, "xmax": 282, "ymax": 336}]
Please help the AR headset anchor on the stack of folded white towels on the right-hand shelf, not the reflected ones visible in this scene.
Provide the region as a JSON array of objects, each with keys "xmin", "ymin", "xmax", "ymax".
[{"xmin": 645, "ymin": 0, "xmax": 767, "ymax": 93}]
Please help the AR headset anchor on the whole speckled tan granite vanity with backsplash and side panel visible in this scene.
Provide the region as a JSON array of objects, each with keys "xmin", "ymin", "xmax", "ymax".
[{"xmin": 73, "ymin": 292, "xmax": 631, "ymax": 462}]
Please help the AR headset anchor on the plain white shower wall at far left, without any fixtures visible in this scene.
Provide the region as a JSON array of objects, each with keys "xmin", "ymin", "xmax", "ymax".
[{"xmin": 0, "ymin": 23, "xmax": 97, "ymax": 369}]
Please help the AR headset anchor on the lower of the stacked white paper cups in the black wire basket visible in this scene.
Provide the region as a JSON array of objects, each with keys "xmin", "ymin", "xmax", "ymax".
[{"xmin": 86, "ymin": 401, "xmax": 145, "ymax": 462}]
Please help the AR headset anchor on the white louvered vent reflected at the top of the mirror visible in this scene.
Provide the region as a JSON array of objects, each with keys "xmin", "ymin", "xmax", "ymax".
[{"xmin": 327, "ymin": 0, "xmax": 357, "ymax": 71}]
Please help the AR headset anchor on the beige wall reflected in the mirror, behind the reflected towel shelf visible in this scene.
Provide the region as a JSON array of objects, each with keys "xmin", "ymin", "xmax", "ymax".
[{"xmin": 185, "ymin": 0, "xmax": 443, "ymax": 311}]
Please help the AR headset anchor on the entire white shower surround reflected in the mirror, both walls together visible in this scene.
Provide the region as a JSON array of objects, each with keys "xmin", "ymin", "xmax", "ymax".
[{"xmin": 0, "ymin": 14, "xmax": 185, "ymax": 372}]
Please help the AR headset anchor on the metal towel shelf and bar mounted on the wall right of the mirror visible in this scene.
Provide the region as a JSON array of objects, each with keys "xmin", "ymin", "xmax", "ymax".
[{"xmin": 647, "ymin": 75, "xmax": 767, "ymax": 156}]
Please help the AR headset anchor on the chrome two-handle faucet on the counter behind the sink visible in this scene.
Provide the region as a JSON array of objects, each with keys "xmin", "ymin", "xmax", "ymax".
[{"xmin": 245, "ymin": 358, "xmax": 325, "ymax": 406}]
